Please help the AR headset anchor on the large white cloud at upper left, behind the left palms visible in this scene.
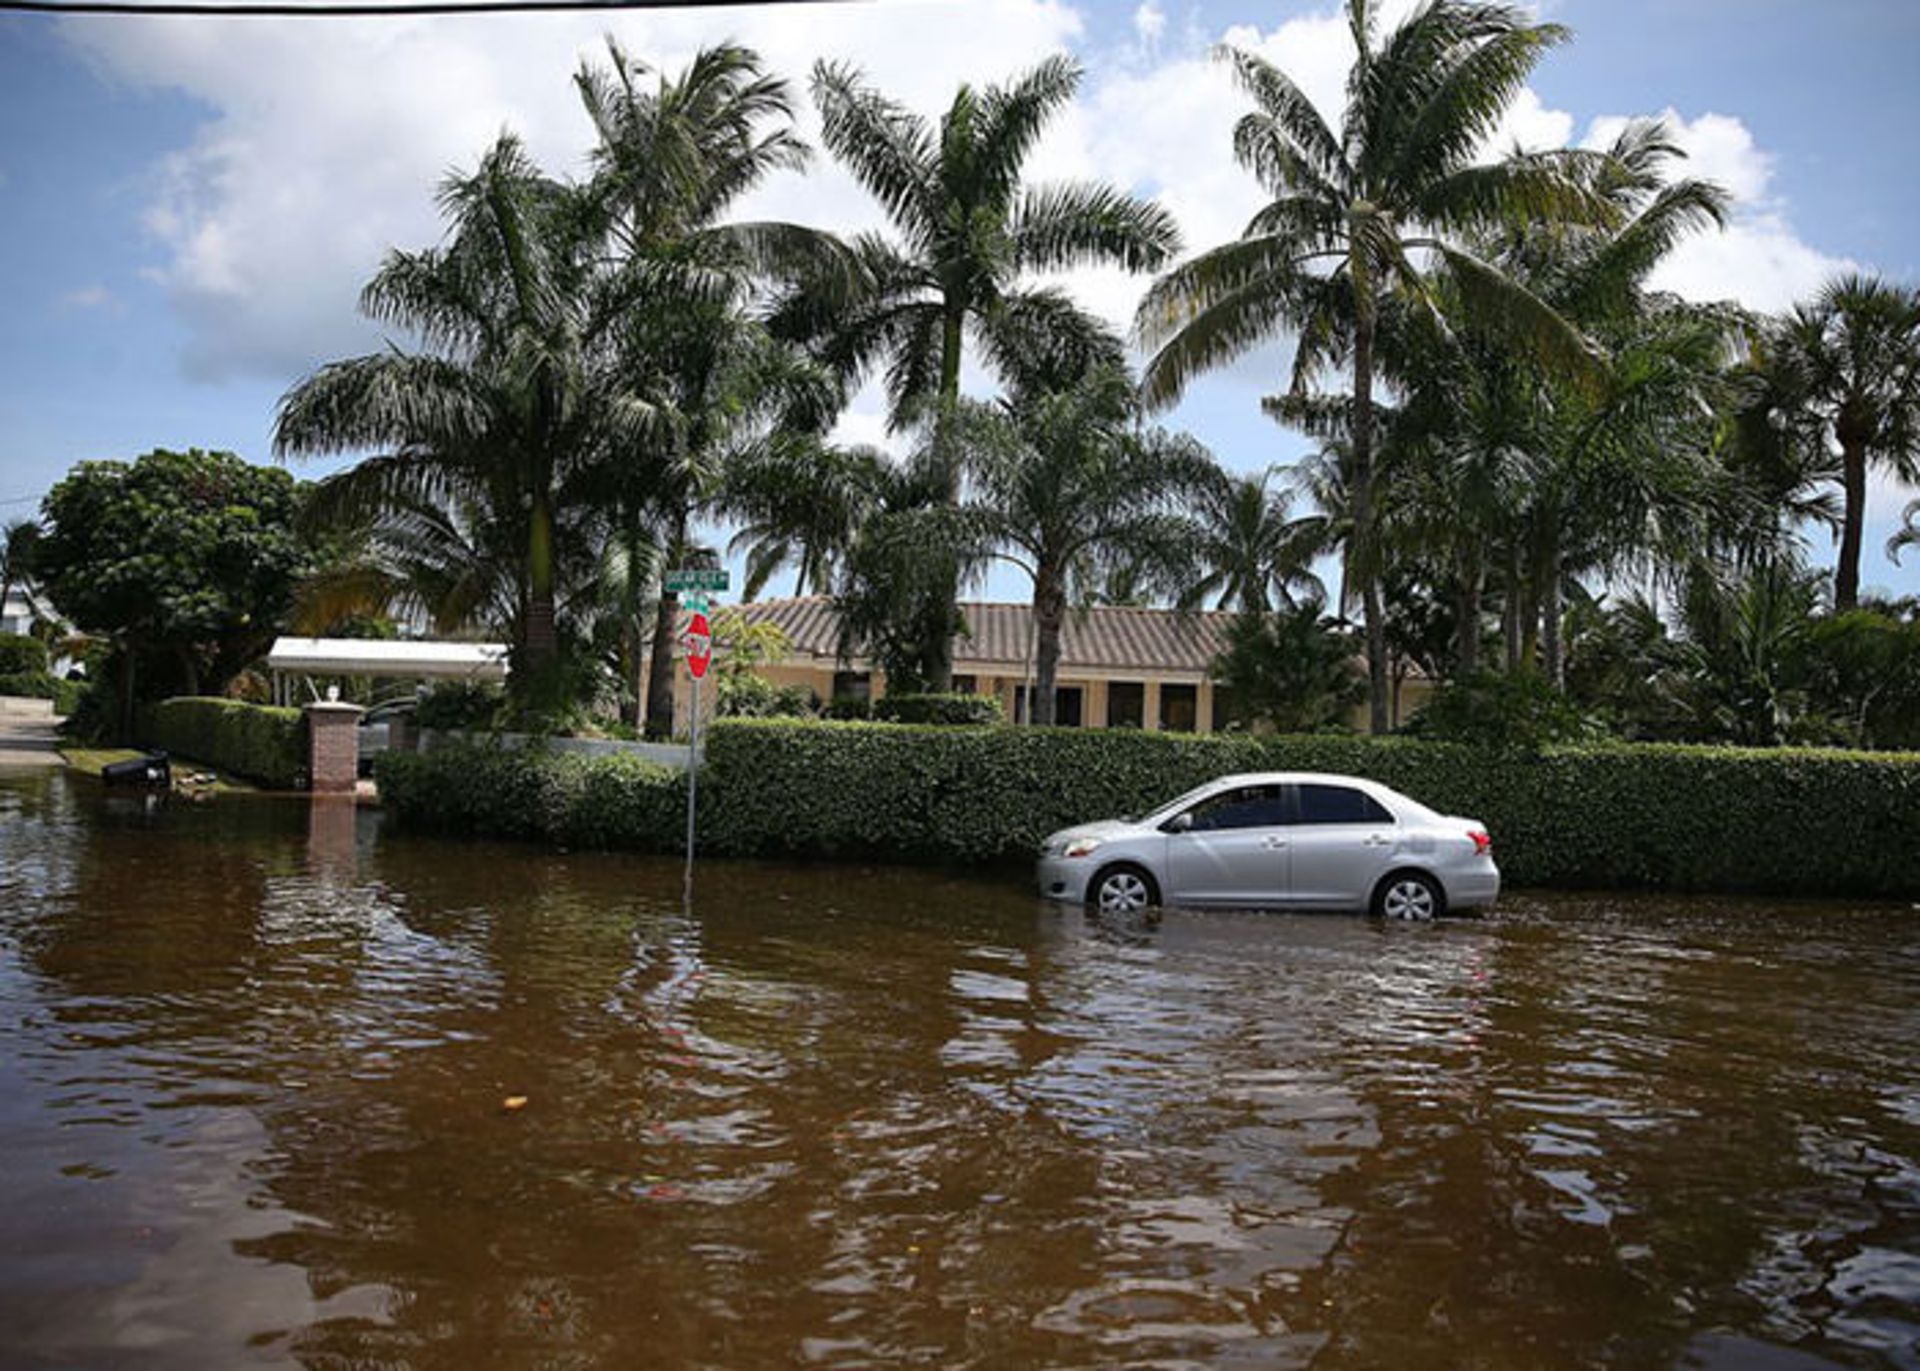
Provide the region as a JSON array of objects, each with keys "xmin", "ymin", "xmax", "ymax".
[{"xmin": 63, "ymin": 0, "xmax": 1081, "ymax": 378}]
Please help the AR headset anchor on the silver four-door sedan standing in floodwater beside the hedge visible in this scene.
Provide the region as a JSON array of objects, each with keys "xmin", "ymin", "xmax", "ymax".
[{"xmin": 1039, "ymin": 772, "xmax": 1500, "ymax": 920}]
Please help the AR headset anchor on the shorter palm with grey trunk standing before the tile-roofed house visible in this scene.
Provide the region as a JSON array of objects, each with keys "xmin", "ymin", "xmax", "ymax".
[{"xmin": 962, "ymin": 367, "xmax": 1221, "ymax": 726}]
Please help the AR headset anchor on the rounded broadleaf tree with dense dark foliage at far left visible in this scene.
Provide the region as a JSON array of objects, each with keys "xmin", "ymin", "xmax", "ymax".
[{"xmin": 33, "ymin": 447, "xmax": 311, "ymax": 734}]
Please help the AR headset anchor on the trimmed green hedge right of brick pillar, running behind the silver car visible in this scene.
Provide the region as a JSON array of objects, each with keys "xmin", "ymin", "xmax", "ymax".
[{"xmin": 376, "ymin": 720, "xmax": 1920, "ymax": 895}]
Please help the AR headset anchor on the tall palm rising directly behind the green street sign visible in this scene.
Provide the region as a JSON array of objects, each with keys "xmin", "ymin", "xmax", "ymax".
[{"xmin": 576, "ymin": 44, "xmax": 851, "ymax": 735}]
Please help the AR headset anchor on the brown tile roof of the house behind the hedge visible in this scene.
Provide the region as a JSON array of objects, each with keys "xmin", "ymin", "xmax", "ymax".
[{"xmin": 737, "ymin": 595, "xmax": 1233, "ymax": 674}]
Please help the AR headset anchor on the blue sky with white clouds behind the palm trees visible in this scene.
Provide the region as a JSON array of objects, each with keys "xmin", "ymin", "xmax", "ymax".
[{"xmin": 0, "ymin": 0, "xmax": 1920, "ymax": 595}]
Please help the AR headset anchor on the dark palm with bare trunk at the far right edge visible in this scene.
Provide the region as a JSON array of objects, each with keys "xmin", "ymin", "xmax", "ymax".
[{"xmin": 1772, "ymin": 275, "xmax": 1920, "ymax": 611}]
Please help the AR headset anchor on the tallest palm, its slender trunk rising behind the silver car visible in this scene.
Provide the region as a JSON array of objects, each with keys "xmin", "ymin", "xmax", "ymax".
[{"xmin": 1137, "ymin": 0, "xmax": 1605, "ymax": 732}]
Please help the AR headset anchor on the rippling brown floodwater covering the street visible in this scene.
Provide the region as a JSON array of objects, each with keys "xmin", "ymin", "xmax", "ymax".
[{"xmin": 0, "ymin": 772, "xmax": 1920, "ymax": 1371}]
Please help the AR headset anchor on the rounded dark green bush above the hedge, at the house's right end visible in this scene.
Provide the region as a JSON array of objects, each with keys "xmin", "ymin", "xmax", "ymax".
[{"xmin": 1213, "ymin": 599, "xmax": 1367, "ymax": 734}]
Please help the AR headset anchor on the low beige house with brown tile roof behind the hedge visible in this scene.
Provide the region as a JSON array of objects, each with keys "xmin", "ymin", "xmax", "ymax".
[{"xmin": 674, "ymin": 595, "xmax": 1425, "ymax": 734}]
